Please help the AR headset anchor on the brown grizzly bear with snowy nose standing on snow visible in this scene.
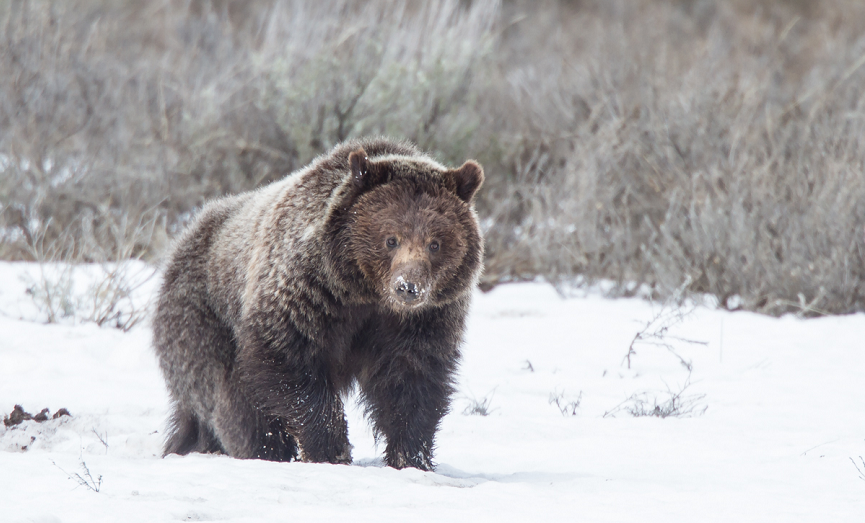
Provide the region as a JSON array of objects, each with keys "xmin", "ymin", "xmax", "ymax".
[{"xmin": 153, "ymin": 138, "xmax": 484, "ymax": 470}]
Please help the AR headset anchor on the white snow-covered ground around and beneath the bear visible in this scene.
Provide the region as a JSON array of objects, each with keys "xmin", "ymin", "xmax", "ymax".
[{"xmin": 0, "ymin": 263, "xmax": 865, "ymax": 522}]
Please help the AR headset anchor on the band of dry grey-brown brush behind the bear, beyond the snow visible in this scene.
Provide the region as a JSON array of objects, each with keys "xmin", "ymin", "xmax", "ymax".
[{"xmin": 0, "ymin": 0, "xmax": 865, "ymax": 314}]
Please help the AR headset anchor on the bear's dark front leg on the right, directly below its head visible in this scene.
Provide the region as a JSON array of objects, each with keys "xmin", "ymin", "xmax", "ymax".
[{"xmin": 360, "ymin": 309, "xmax": 463, "ymax": 470}]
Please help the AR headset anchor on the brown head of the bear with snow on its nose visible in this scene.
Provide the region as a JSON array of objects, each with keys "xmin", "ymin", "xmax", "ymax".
[{"xmin": 346, "ymin": 148, "xmax": 484, "ymax": 313}]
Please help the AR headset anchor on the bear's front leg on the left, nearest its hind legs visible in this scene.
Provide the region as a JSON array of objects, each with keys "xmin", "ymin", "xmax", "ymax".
[{"xmin": 238, "ymin": 327, "xmax": 351, "ymax": 464}]
